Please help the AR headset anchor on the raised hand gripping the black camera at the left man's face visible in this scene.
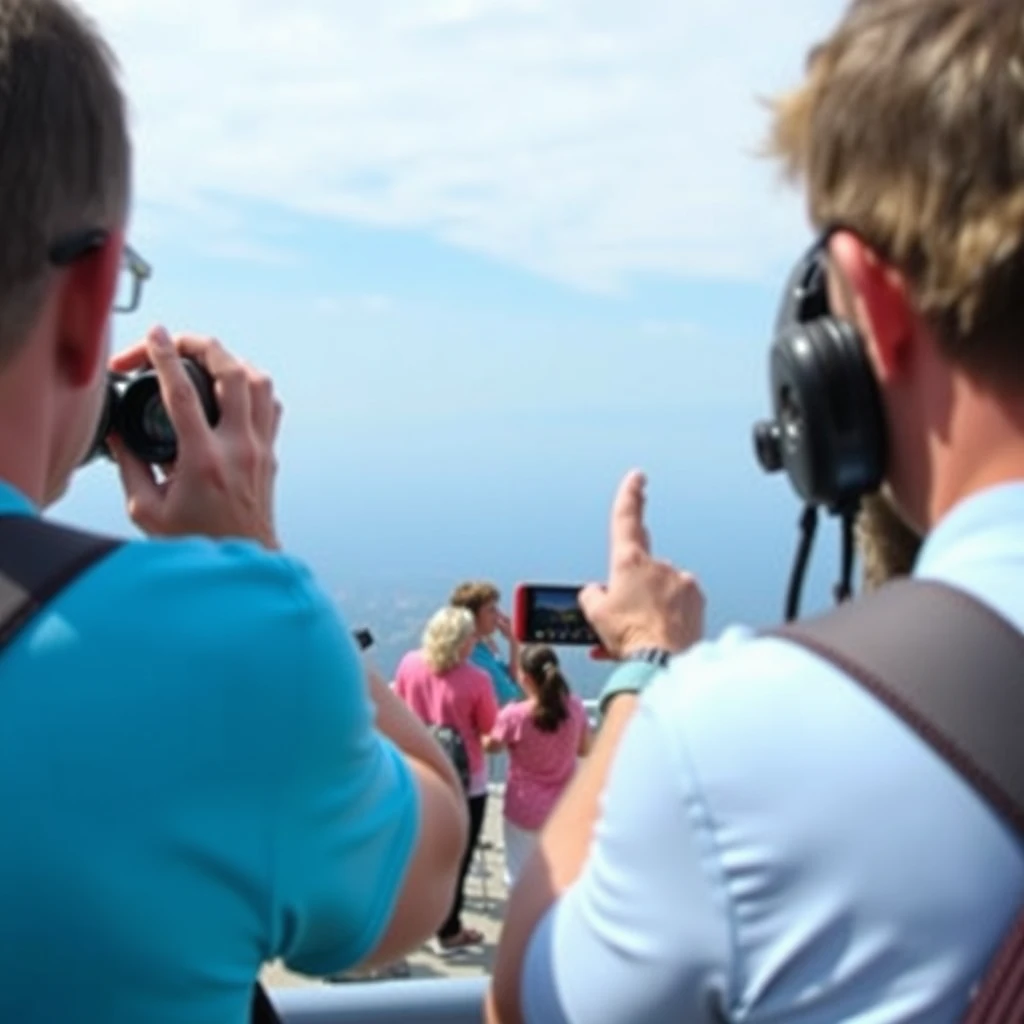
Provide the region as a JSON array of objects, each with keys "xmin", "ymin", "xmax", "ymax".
[{"xmin": 111, "ymin": 328, "xmax": 282, "ymax": 549}]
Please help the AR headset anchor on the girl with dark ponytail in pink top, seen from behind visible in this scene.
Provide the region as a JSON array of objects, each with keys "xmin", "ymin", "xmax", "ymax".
[{"xmin": 484, "ymin": 645, "xmax": 591, "ymax": 888}]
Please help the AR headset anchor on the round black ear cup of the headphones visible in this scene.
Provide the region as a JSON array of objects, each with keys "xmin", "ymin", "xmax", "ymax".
[{"xmin": 771, "ymin": 316, "xmax": 886, "ymax": 511}]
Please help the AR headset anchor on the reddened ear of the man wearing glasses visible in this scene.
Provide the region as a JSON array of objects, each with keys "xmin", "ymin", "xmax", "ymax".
[{"xmin": 56, "ymin": 231, "xmax": 124, "ymax": 388}]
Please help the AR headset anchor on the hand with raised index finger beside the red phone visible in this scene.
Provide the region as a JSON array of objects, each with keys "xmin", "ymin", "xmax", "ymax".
[{"xmin": 580, "ymin": 472, "xmax": 705, "ymax": 657}]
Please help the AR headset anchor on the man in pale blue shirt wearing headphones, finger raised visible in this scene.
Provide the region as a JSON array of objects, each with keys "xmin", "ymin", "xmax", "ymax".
[{"xmin": 488, "ymin": 0, "xmax": 1024, "ymax": 1024}]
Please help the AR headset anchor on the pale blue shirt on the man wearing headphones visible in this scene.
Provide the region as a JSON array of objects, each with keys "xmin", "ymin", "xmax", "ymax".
[{"xmin": 521, "ymin": 484, "xmax": 1024, "ymax": 1024}]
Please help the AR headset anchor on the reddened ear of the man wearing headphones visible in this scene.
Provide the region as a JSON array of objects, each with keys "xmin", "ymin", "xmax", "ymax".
[{"xmin": 828, "ymin": 231, "xmax": 916, "ymax": 381}]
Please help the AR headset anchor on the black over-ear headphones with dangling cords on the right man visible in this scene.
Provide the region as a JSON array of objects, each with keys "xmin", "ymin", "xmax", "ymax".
[{"xmin": 754, "ymin": 230, "xmax": 887, "ymax": 618}]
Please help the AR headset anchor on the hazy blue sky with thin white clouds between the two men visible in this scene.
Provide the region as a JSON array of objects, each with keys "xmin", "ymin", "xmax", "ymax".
[{"xmin": 57, "ymin": 0, "xmax": 856, "ymax": 663}]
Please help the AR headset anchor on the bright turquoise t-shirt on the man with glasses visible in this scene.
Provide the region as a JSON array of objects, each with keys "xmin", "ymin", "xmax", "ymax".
[{"xmin": 0, "ymin": 485, "xmax": 419, "ymax": 1024}]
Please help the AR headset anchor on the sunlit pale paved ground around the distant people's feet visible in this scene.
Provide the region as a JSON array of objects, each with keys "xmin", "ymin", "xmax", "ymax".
[{"xmin": 263, "ymin": 791, "xmax": 506, "ymax": 986}]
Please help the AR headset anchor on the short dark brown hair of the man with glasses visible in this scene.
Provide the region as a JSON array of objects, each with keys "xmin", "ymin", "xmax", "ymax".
[{"xmin": 0, "ymin": 0, "xmax": 131, "ymax": 362}]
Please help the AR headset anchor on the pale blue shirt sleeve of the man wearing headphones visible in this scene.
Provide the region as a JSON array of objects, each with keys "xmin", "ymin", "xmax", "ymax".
[{"xmin": 521, "ymin": 679, "xmax": 731, "ymax": 1024}]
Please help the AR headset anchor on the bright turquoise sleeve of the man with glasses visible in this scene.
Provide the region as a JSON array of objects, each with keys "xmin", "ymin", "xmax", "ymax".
[{"xmin": 266, "ymin": 561, "xmax": 419, "ymax": 975}]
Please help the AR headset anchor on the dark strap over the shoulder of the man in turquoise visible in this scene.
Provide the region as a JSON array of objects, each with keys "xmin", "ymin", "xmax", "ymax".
[{"xmin": 0, "ymin": 515, "xmax": 280, "ymax": 1024}]
